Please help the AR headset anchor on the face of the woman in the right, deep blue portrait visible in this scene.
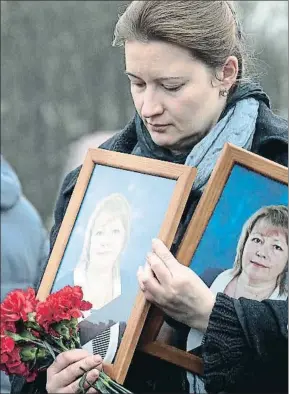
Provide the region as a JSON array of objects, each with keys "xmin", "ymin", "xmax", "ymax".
[{"xmin": 242, "ymin": 219, "xmax": 288, "ymax": 282}]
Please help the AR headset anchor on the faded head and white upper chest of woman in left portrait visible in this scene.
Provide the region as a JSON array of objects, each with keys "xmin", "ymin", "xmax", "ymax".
[{"xmin": 74, "ymin": 193, "xmax": 130, "ymax": 309}]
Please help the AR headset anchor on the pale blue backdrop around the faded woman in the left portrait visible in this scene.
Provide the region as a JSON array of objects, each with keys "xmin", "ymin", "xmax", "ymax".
[{"xmin": 52, "ymin": 165, "xmax": 176, "ymax": 323}]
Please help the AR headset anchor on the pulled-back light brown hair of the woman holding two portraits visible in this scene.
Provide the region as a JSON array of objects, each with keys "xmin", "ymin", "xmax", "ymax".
[{"xmin": 113, "ymin": 0, "xmax": 246, "ymax": 87}]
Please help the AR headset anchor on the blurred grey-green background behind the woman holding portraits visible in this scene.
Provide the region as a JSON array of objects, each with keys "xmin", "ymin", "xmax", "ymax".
[{"xmin": 1, "ymin": 1, "xmax": 288, "ymax": 230}]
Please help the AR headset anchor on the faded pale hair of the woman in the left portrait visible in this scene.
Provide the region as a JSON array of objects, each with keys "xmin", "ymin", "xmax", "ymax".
[{"xmin": 76, "ymin": 193, "xmax": 131, "ymax": 269}]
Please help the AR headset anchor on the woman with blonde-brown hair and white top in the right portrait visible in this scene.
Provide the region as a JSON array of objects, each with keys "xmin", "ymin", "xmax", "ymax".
[{"xmin": 187, "ymin": 205, "xmax": 288, "ymax": 393}]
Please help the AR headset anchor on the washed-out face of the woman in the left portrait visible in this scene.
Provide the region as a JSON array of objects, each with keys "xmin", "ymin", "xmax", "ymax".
[{"xmin": 89, "ymin": 212, "xmax": 125, "ymax": 268}]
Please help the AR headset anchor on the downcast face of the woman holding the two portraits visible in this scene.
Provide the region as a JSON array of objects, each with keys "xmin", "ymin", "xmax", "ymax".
[{"xmin": 125, "ymin": 41, "xmax": 225, "ymax": 150}]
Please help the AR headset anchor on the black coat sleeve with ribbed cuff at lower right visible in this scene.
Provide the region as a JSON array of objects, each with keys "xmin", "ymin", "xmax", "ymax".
[{"xmin": 202, "ymin": 293, "xmax": 288, "ymax": 394}]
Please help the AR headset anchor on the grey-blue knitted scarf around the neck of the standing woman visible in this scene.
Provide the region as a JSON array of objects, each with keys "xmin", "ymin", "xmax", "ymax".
[{"xmin": 132, "ymin": 97, "xmax": 259, "ymax": 192}]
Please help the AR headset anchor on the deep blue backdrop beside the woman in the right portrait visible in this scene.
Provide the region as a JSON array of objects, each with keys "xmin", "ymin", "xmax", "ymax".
[{"xmin": 190, "ymin": 165, "xmax": 288, "ymax": 277}]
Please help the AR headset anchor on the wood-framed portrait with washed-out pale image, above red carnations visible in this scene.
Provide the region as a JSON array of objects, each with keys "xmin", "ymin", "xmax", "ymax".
[{"xmin": 37, "ymin": 149, "xmax": 196, "ymax": 384}]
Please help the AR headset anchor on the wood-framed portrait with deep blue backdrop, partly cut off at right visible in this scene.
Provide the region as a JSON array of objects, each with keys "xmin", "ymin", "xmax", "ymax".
[{"xmin": 139, "ymin": 144, "xmax": 288, "ymax": 375}]
